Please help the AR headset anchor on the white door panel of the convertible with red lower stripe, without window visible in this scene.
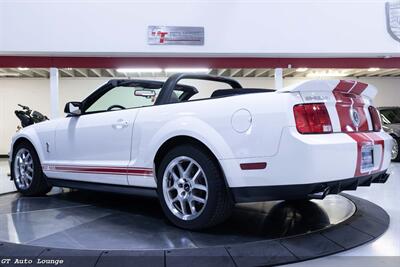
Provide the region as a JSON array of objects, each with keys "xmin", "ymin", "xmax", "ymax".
[{"xmin": 53, "ymin": 109, "xmax": 137, "ymax": 184}]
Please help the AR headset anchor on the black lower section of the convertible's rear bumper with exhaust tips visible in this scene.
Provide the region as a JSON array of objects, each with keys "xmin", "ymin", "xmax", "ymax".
[{"xmin": 230, "ymin": 170, "xmax": 390, "ymax": 203}]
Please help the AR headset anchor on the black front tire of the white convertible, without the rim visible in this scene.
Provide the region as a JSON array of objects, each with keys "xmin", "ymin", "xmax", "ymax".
[{"xmin": 11, "ymin": 142, "xmax": 52, "ymax": 196}]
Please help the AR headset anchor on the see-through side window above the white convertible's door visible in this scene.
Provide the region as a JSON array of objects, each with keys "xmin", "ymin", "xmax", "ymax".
[{"xmin": 86, "ymin": 86, "xmax": 160, "ymax": 113}]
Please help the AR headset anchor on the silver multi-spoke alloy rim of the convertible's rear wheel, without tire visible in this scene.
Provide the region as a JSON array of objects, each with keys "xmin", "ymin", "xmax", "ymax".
[{"xmin": 162, "ymin": 156, "xmax": 208, "ymax": 221}]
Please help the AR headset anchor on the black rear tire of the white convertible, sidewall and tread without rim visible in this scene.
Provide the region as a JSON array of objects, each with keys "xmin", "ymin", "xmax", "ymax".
[{"xmin": 157, "ymin": 144, "xmax": 234, "ymax": 230}]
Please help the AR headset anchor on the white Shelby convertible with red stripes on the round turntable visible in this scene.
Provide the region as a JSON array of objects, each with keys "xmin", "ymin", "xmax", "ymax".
[{"xmin": 10, "ymin": 74, "xmax": 392, "ymax": 229}]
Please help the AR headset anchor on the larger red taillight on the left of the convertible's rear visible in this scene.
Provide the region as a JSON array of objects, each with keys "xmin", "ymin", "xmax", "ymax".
[{"xmin": 293, "ymin": 103, "xmax": 332, "ymax": 134}]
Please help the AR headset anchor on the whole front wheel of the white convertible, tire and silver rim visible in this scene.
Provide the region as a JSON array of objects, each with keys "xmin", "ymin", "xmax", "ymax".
[{"xmin": 11, "ymin": 143, "xmax": 51, "ymax": 196}]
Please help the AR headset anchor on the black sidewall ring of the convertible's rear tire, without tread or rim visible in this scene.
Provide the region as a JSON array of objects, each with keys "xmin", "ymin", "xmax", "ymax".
[{"xmin": 157, "ymin": 145, "xmax": 225, "ymax": 229}]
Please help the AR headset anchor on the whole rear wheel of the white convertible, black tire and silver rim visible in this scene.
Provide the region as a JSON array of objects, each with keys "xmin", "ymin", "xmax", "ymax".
[{"xmin": 157, "ymin": 145, "xmax": 233, "ymax": 230}]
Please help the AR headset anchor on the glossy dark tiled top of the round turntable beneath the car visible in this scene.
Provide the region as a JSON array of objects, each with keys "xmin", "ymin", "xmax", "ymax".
[{"xmin": 0, "ymin": 189, "xmax": 355, "ymax": 250}]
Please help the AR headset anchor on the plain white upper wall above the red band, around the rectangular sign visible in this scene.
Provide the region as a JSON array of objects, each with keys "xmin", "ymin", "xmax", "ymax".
[{"xmin": 0, "ymin": 0, "xmax": 400, "ymax": 57}]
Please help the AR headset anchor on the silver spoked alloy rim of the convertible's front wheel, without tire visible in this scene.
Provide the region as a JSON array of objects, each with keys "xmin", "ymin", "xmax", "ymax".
[{"xmin": 14, "ymin": 148, "xmax": 34, "ymax": 190}]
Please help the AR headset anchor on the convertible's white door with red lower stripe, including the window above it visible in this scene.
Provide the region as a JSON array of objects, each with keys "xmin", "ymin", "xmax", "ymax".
[{"xmin": 46, "ymin": 86, "xmax": 154, "ymax": 185}]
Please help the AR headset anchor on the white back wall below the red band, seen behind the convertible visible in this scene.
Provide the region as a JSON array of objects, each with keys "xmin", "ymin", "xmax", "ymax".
[{"xmin": 0, "ymin": 78, "xmax": 400, "ymax": 154}]
